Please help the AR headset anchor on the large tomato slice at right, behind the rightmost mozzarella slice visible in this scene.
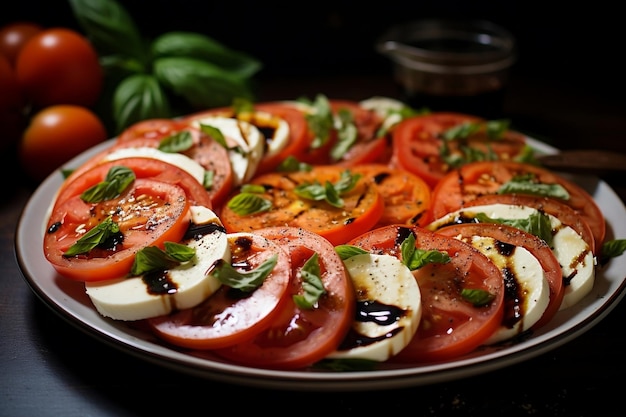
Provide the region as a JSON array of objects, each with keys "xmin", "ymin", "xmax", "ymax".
[{"xmin": 432, "ymin": 161, "xmax": 606, "ymax": 248}]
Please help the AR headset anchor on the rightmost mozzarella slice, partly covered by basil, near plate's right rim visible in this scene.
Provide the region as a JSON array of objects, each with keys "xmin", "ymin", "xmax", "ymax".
[{"xmin": 428, "ymin": 204, "xmax": 596, "ymax": 310}]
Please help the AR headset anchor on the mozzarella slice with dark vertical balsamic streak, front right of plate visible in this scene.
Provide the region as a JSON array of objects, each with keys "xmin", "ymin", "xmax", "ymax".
[{"xmin": 470, "ymin": 236, "xmax": 550, "ymax": 344}]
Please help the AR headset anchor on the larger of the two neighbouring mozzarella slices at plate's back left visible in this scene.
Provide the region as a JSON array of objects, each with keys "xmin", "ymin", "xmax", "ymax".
[{"xmin": 193, "ymin": 116, "xmax": 265, "ymax": 186}]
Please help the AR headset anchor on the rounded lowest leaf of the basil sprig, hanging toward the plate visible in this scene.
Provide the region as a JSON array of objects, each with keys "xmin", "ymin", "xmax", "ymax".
[{"xmin": 113, "ymin": 74, "xmax": 171, "ymax": 132}]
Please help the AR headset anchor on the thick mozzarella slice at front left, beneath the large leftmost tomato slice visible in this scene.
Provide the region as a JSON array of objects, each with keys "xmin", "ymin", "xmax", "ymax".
[{"xmin": 85, "ymin": 206, "xmax": 230, "ymax": 321}]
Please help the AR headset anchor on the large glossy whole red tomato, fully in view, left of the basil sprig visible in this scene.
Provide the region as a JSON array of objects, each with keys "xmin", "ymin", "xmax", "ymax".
[{"xmin": 15, "ymin": 28, "xmax": 103, "ymax": 108}]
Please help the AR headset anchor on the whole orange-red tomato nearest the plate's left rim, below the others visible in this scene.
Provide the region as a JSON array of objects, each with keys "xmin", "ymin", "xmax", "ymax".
[{"xmin": 19, "ymin": 105, "xmax": 107, "ymax": 181}]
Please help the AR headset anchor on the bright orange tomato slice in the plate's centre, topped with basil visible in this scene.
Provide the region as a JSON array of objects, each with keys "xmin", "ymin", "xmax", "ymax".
[{"xmin": 220, "ymin": 165, "xmax": 384, "ymax": 245}]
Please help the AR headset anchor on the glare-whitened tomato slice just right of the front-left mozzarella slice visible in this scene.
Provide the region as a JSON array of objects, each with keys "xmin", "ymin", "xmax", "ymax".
[{"xmin": 147, "ymin": 233, "xmax": 291, "ymax": 349}]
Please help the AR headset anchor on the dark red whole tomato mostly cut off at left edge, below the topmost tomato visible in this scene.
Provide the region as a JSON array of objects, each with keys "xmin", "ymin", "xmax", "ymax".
[{"xmin": 0, "ymin": 54, "xmax": 25, "ymax": 151}]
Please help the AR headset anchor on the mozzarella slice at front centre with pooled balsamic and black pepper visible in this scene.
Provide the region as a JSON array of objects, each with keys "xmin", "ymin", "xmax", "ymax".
[{"xmin": 328, "ymin": 254, "xmax": 422, "ymax": 362}]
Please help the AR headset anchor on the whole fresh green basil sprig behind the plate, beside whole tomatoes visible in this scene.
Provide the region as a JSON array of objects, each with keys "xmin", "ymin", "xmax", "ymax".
[{"xmin": 69, "ymin": 0, "xmax": 262, "ymax": 132}]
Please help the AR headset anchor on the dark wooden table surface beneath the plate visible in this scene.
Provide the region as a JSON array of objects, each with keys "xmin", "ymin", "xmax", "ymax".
[{"xmin": 0, "ymin": 76, "xmax": 626, "ymax": 417}]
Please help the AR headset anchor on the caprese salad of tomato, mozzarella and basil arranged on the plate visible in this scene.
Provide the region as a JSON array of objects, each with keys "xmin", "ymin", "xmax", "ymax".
[{"xmin": 43, "ymin": 95, "xmax": 626, "ymax": 370}]
